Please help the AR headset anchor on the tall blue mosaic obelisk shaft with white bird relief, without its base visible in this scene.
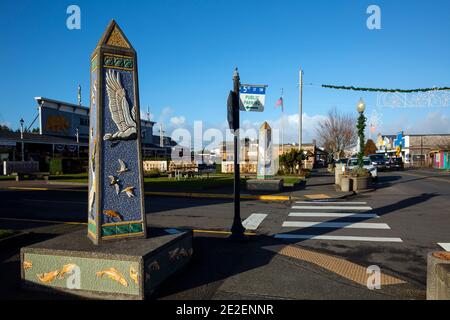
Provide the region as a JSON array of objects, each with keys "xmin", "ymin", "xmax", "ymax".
[{"xmin": 88, "ymin": 20, "xmax": 146, "ymax": 244}]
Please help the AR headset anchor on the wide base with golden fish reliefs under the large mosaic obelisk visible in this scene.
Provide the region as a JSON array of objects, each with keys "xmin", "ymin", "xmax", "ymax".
[{"xmin": 20, "ymin": 229, "xmax": 193, "ymax": 300}]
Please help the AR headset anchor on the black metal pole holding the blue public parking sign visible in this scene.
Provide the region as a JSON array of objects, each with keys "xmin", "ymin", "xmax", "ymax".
[{"xmin": 231, "ymin": 68, "xmax": 245, "ymax": 239}]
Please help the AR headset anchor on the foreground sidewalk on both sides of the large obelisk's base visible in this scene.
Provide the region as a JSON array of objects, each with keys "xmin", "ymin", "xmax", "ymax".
[{"xmin": 0, "ymin": 226, "xmax": 425, "ymax": 300}]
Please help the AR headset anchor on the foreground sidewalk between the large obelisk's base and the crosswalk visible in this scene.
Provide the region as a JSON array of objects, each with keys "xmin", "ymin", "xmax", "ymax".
[{"xmin": 156, "ymin": 236, "xmax": 425, "ymax": 300}]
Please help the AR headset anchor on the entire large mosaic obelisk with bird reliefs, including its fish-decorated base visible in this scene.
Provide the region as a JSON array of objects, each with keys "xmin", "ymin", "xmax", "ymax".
[{"xmin": 20, "ymin": 20, "xmax": 193, "ymax": 299}]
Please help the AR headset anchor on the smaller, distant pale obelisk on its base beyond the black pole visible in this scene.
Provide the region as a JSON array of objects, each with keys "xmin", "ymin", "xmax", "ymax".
[{"xmin": 247, "ymin": 122, "xmax": 283, "ymax": 191}]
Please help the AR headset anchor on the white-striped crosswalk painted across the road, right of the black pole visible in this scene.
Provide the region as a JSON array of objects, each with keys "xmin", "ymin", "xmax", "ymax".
[{"xmin": 274, "ymin": 201, "xmax": 403, "ymax": 242}]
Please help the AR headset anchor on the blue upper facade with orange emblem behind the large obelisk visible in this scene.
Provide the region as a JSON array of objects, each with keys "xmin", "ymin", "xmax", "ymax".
[{"xmin": 0, "ymin": 97, "xmax": 176, "ymax": 169}]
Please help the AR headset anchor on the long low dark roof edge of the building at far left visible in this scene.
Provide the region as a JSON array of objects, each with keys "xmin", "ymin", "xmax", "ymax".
[{"xmin": 0, "ymin": 131, "xmax": 88, "ymax": 146}]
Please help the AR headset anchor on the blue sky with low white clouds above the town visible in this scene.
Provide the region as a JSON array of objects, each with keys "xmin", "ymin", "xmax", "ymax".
[{"xmin": 0, "ymin": 0, "xmax": 450, "ymax": 141}]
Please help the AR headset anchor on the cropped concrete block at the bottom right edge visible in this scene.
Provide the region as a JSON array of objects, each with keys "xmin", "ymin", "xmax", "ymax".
[{"xmin": 427, "ymin": 251, "xmax": 450, "ymax": 300}]
